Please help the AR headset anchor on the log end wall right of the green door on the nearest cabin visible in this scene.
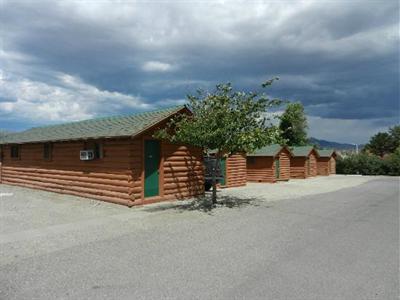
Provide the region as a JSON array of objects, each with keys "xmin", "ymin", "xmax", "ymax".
[{"xmin": 162, "ymin": 143, "xmax": 204, "ymax": 199}]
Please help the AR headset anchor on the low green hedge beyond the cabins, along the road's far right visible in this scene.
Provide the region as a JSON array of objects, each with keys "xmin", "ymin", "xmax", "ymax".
[{"xmin": 336, "ymin": 151, "xmax": 400, "ymax": 176}]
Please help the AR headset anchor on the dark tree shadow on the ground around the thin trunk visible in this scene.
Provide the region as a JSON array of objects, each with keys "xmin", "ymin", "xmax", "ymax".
[{"xmin": 143, "ymin": 193, "xmax": 261, "ymax": 213}]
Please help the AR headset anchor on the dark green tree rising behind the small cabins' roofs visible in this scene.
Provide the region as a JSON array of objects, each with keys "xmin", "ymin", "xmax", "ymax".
[{"xmin": 279, "ymin": 102, "xmax": 308, "ymax": 146}]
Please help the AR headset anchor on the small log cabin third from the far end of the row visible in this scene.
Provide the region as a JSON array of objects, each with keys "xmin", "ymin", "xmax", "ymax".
[{"xmin": 247, "ymin": 144, "xmax": 291, "ymax": 183}]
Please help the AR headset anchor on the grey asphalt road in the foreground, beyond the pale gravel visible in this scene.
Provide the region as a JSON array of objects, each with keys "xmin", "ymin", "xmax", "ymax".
[{"xmin": 0, "ymin": 177, "xmax": 399, "ymax": 300}]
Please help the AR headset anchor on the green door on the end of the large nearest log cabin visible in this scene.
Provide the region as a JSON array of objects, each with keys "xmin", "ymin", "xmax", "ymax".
[{"xmin": 144, "ymin": 140, "xmax": 160, "ymax": 197}]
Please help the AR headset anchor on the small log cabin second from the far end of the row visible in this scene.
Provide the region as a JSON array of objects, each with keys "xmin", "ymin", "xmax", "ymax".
[{"xmin": 290, "ymin": 146, "xmax": 318, "ymax": 178}]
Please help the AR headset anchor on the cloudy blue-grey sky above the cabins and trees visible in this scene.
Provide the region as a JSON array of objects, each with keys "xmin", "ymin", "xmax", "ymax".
[{"xmin": 0, "ymin": 0, "xmax": 400, "ymax": 143}]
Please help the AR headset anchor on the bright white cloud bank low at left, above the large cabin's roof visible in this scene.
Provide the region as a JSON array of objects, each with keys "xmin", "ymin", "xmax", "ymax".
[{"xmin": 0, "ymin": 70, "xmax": 151, "ymax": 123}]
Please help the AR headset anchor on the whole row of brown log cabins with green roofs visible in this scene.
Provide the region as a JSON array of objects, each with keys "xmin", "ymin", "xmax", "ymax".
[{"xmin": 0, "ymin": 107, "xmax": 335, "ymax": 206}]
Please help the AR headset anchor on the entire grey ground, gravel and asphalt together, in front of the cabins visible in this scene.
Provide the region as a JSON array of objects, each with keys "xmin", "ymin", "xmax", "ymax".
[{"xmin": 0, "ymin": 175, "xmax": 399, "ymax": 300}]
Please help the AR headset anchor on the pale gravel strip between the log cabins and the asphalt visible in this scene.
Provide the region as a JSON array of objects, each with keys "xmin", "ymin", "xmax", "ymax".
[{"xmin": 0, "ymin": 175, "xmax": 374, "ymax": 265}]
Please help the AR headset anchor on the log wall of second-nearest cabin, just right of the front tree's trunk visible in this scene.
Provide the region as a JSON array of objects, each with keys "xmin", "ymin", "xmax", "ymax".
[{"xmin": 224, "ymin": 154, "xmax": 247, "ymax": 187}]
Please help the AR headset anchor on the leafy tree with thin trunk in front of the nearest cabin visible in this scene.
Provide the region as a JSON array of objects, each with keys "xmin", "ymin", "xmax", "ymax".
[{"xmin": 155, "ymin": 78, "xmax": 281, "ymax": 204}]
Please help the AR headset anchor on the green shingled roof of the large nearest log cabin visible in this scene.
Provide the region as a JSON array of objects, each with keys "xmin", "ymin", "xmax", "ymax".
[{"xmin": 0, "ymin": 106, "xmax": 184, "ymax": 144}]
